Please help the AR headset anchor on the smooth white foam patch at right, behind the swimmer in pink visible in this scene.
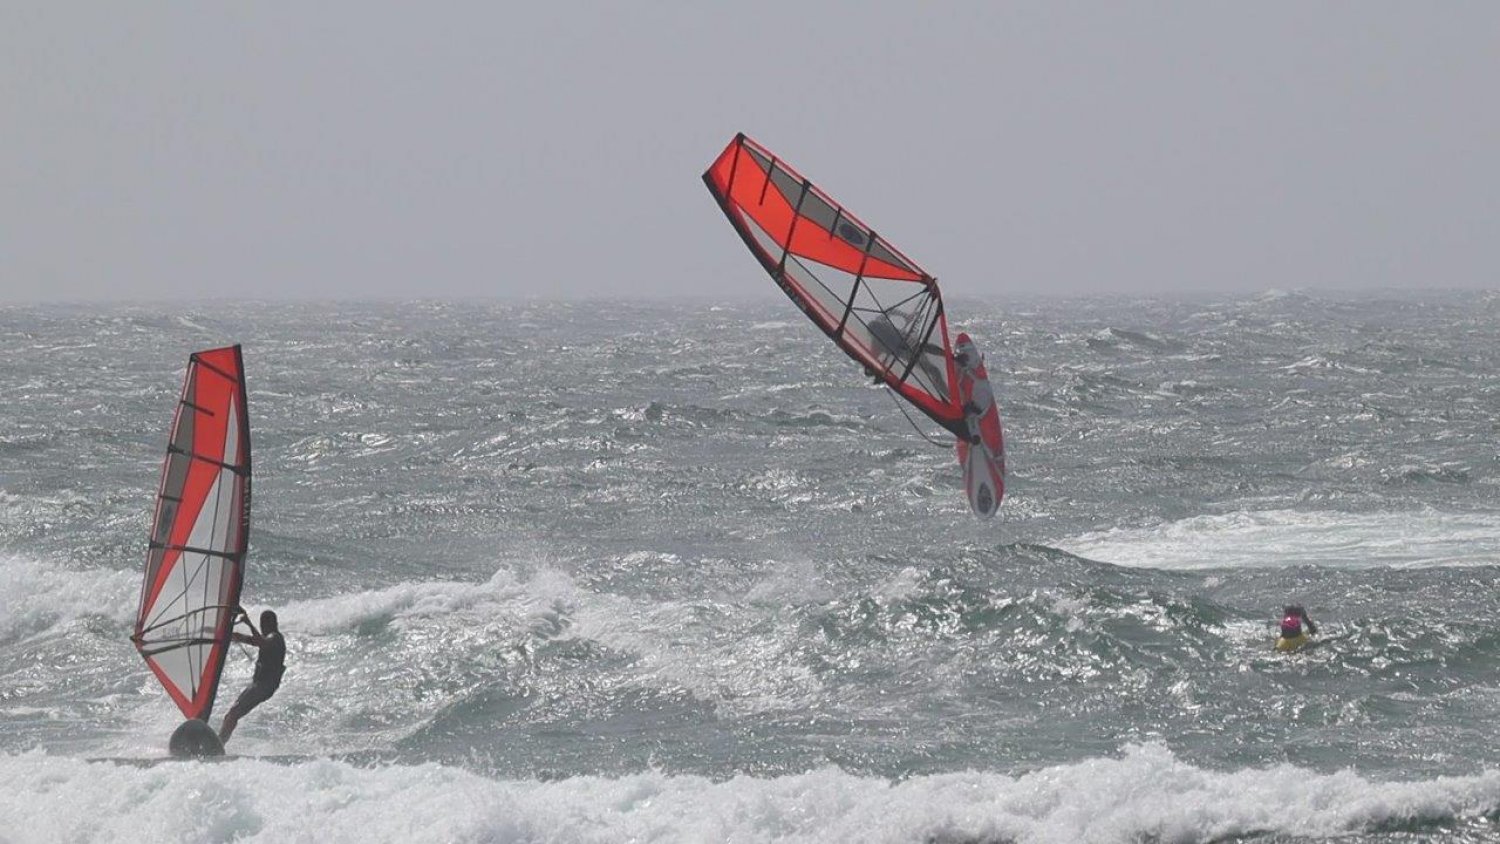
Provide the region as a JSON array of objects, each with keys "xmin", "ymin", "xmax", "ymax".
[{"xmin": 1058, "ymin": 510, "xmax": 1500, "ymax": 568}]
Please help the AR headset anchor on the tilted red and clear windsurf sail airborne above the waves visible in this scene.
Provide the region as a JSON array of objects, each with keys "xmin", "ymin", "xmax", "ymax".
[{"xmin": 704, "ymin": 133, "xmax": 968, "ymax": 436}]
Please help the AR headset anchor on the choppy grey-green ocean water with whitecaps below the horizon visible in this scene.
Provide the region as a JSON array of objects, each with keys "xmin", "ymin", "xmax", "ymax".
[{"xmin": 0, "ymin": 294, "xmax": 1500, "ymax": 843}]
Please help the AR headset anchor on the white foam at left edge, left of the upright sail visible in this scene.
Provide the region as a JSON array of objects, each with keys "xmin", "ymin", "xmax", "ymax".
[{"xmin": 0, "ymin": 555, "xmax": 141, "ymax": 642}]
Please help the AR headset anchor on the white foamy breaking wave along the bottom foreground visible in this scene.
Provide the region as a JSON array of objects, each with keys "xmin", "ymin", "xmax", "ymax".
[{"xmin": 0, "ymin": 745, "xmax": 1500, "ymax": 844}]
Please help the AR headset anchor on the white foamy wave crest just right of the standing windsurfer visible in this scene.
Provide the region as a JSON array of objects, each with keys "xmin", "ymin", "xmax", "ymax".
[{"xmin": 273, "ymin": 560, "xmax": 821, "ymax": 712}]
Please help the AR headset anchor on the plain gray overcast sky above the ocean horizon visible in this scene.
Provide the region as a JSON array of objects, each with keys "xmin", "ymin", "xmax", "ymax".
[{"xmin": 0, "ymin": 0, "xmax": 1500, "ymax": 301}]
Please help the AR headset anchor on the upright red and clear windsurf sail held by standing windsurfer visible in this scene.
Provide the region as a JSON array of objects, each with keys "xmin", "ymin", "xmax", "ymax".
[{"xmin": 131, "ymin": 345, "xmax": 251, "ymax": 720}]
